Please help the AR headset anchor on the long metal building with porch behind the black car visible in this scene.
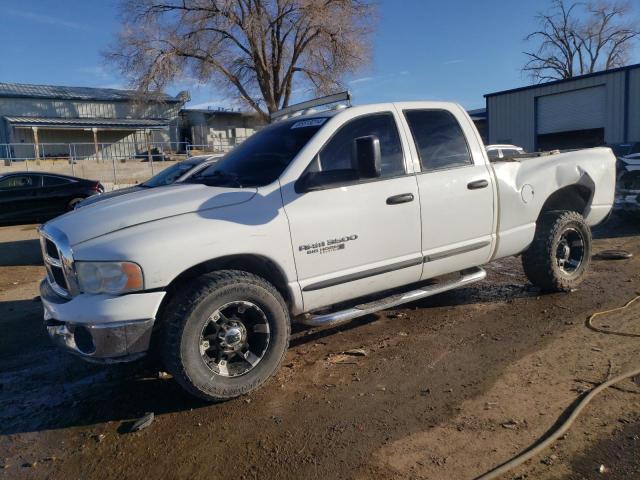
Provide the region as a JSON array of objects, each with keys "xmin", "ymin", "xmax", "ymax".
[{"xmin": 0, "ymin": 83, "xmax": 189, "ymax": 159}]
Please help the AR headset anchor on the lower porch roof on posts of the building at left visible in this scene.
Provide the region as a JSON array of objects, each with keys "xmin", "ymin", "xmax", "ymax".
[{"xmin": 4, "ymin": 117, "xmax": 169, "ymax": 129}]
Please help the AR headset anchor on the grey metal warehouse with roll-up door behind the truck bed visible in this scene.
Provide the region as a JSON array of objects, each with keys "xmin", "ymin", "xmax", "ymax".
[{"xmin": 485, "ymin": 64, "xmax": 640, "ymax": 151}]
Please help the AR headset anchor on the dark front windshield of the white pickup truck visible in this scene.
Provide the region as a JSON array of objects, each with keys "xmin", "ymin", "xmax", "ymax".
[{"xmin": 188, "ymin": 117, "xmax": 327, "ymax": 188}]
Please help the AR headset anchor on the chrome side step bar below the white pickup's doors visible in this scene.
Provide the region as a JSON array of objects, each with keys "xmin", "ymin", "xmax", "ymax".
[{"xmin": 300, "ymin": 267, "xmax": 487, "ymax": 327}]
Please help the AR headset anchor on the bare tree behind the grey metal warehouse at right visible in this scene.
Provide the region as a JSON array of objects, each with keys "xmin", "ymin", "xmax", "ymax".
[{"xmin": 522, "ymin": 0, "xmax": 640, "ymax": 82}]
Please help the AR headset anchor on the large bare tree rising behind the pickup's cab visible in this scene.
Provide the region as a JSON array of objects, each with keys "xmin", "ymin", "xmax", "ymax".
[{"xmin": 105, "ymin": 0, "xmax": 375, "ymax": 120}]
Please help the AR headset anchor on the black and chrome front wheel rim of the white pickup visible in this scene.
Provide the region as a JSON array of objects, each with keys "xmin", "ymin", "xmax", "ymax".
[{"xmin": 200, "ymin": 301, "xmax": 270, "ymax": 377}]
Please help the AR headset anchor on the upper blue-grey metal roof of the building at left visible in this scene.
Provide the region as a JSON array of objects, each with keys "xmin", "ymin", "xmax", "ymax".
[{"xmin": 0, "ymin": 83, "xmax": 183, "ymax": 103}]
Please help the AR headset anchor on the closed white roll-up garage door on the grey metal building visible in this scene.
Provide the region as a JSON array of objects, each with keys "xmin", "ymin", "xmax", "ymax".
[{"xmin": 536, "ymin": 86, "xmax": 606, "ymax": 134}]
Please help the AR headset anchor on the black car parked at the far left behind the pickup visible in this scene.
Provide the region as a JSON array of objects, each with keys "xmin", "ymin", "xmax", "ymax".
[{"xmin": 0, "ymin": 172, "xmax": 104, "ymax": 224}]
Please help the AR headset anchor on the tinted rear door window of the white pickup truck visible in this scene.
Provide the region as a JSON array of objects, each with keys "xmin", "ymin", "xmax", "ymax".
[{"xmin": 404, "ymin": 110, "xmax": 473, "ymax": 171}]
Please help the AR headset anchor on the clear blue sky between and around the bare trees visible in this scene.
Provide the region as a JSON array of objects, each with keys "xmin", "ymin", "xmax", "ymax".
[{"xmin": 0, "ymin": 0, "xmax": 640, "ymax": 108}]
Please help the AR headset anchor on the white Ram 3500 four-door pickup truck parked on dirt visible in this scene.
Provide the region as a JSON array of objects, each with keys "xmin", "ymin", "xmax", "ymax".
[{"xmin": 40, "ymin": 97, "xmax": 615, "ymax": 401}]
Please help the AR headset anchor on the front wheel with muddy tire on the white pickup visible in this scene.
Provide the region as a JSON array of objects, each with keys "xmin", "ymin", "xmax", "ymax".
[{"xmin": 161, "ymin": 270, "xmax": 291, "ymax": 402}]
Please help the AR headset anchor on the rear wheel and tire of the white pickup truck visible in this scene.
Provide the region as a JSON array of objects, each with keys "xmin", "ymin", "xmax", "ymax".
[{"xmin": 522, "ymin": 210, "xmax": 592, "ymax": 292}]
